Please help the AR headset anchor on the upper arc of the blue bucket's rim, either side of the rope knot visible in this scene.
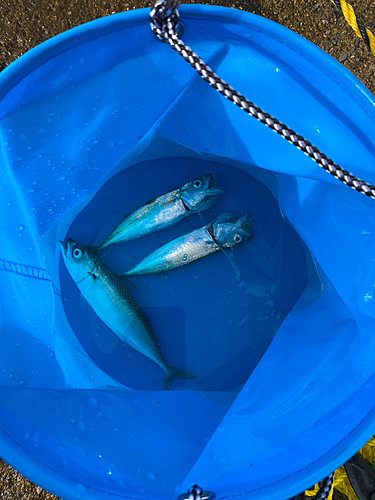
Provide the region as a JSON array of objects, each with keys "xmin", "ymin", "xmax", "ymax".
[{"xmin": 0, "ymin": 4, "xmax": 375, "ymax": 107}]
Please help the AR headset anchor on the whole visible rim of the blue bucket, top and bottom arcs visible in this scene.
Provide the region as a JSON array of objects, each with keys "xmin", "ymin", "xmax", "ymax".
[{"xmin": 0, "ymin": 5, "xmax": 375, "ymax": 500}]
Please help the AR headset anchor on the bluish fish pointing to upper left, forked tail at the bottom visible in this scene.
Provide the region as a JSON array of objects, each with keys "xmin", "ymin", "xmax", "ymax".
[{"xmin": 60, "ymin": 238, "xmax": 195, "ymax": 389}]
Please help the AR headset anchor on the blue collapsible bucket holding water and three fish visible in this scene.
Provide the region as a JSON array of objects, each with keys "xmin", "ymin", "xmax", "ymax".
[{"xmin": 0, "ymin": 5, "xmax": 375, "ymax": 500}]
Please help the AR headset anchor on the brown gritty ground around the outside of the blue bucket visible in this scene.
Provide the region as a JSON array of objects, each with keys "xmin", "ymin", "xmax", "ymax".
[{"xmin": 0, "ymin": 0, "xmax": 375, "ymax": 500}]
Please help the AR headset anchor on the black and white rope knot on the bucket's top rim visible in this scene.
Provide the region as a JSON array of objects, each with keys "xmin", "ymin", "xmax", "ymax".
[{"xmin": 150, "ymin": 0, "xmax": 180, "ymax": 40}]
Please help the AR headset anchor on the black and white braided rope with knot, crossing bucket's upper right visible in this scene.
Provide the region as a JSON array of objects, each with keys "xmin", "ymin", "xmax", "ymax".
[{"xmin": 150, "ymin": 0, "xmax": 375, "ymax": 199}]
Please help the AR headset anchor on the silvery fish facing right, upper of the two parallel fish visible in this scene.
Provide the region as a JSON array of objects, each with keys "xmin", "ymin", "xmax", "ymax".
[{"xmin": 91, "ymin": 174, "xmax": 224, "ymax": 253}]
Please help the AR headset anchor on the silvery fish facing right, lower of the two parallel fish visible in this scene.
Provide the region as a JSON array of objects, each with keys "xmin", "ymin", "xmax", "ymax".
[{"xmin": 120, "ymin": 212, "xmax": 253, "ymax": 277}]
